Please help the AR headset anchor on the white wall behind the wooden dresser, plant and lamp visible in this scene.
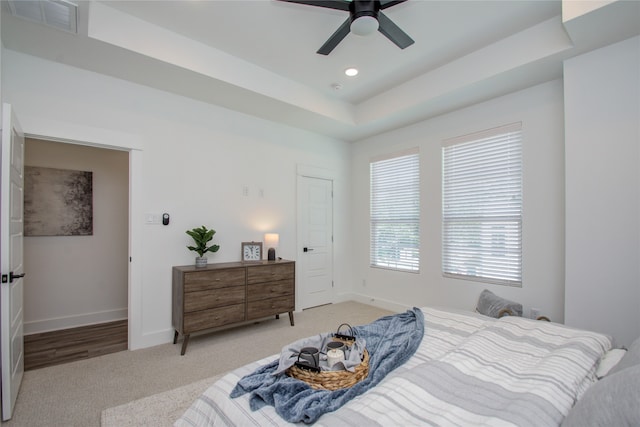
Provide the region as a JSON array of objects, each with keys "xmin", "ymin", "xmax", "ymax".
[{"xmin": 2, "ymin": 50, "xmax": 349, "ymax": 348}]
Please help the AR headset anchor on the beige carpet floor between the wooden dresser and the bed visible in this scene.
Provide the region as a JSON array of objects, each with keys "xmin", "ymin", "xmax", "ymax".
[{"xmin": 2, "ymin": 302, "xmax": 390, "ymax": 427}]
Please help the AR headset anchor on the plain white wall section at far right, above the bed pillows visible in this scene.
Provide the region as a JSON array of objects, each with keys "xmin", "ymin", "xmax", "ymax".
[{"xmin": 564, "ymin": 37, "xmax": 640, "ymax": 345}]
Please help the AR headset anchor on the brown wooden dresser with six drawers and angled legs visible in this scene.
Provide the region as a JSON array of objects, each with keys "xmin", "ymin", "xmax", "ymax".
[{"xmin": 172, "ymin": 260, "xmax": 296, "ymax": 355}]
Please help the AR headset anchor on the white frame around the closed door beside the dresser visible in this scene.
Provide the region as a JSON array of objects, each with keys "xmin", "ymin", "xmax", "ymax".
[{"xmin": 296, "ymin": 164, "xmax": 336, "ymax": 311}]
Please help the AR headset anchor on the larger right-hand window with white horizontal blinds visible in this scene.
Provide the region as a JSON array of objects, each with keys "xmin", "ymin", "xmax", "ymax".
[{"xmin": 442, "ymin": 123, "xmax": 522, "ymax": 286}]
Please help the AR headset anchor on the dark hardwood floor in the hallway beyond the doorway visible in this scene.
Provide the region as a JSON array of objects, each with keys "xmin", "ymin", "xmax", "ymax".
[{"xmin": 24, "ymin": 320, "xmax": 128, "ymax": 371}]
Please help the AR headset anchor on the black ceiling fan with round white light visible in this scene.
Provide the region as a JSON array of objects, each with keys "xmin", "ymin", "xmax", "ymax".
[{"xmin": 280, "ymin": 0, "xmax": 414, "ymax": 55}]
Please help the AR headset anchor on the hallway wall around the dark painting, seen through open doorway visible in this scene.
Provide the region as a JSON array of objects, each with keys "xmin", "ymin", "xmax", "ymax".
[{"xmin": 24, "ymin": 138, "xmax": 129, "ymax": 334}]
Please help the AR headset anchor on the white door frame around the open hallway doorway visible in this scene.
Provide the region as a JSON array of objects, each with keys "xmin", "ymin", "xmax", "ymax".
[{"xmin": 21, "ymin": 117, "xmax": 144, "ymax": 350}]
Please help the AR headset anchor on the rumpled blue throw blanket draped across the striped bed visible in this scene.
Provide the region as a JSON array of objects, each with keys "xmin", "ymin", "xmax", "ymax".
[{"xmin": 231, "ymin": 308, "xmax": 424, "ymax": 423}]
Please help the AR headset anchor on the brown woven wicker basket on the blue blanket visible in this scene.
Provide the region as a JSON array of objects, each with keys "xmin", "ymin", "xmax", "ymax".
[{"xmin": 287, "ymin": 349, "xmax": 369, "ymax": 391}]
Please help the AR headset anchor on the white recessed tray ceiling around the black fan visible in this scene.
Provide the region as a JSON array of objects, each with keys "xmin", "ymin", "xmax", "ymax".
[{"xmin": 1, "ymin": 0, "xmax": 640, "ymax": 140}]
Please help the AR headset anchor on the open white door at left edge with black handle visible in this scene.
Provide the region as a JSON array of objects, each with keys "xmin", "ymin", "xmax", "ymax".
[{"xmin": 0, "ymin": 104, "xmax": 24, "ymax": 421}]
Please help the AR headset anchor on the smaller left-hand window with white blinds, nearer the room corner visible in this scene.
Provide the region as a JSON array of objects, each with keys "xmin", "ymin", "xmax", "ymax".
[{"xmin": 370, "ymin": 148, "xmax": 420, "ymax": 272}]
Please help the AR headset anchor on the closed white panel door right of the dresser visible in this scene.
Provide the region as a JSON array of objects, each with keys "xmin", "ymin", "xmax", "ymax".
[{"xmin": 297, "ymin": 176, "xmax": 333, "ymax": 309}]
